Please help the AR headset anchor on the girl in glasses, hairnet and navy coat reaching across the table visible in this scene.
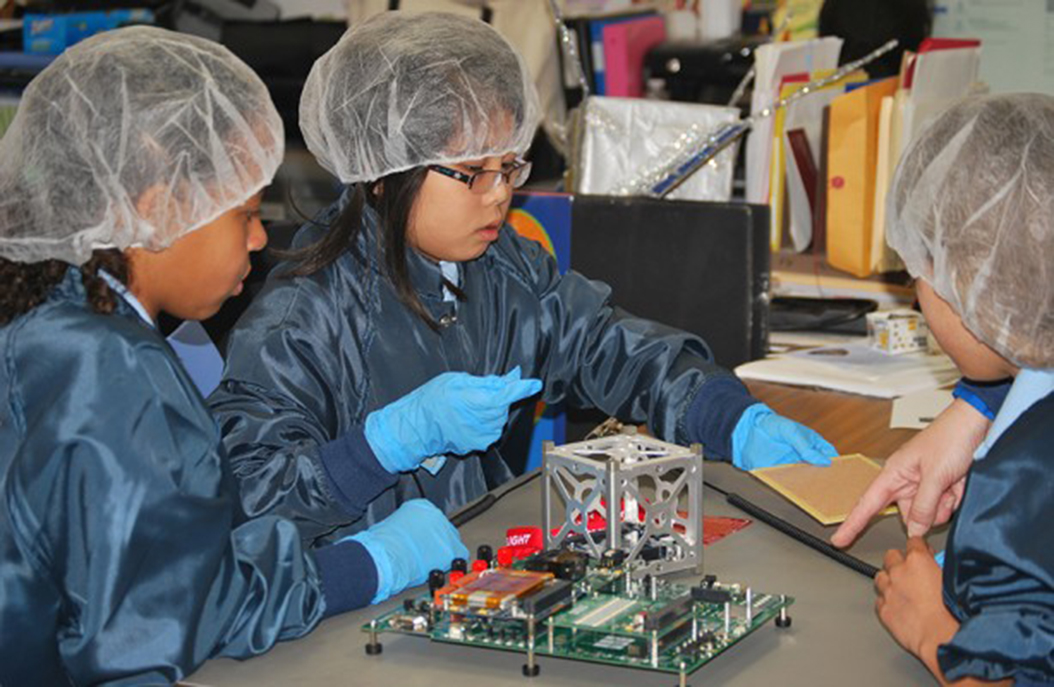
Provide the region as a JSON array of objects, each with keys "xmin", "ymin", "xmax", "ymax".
[{"xmin": 210, "ymin": 12, "xmax": 835, "ymax": 548}]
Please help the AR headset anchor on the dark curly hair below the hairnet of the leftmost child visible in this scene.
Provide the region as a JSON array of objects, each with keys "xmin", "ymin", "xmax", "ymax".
[{"xmin": 0, "ymin": 249, "xmax": 129, "ymax": 327}]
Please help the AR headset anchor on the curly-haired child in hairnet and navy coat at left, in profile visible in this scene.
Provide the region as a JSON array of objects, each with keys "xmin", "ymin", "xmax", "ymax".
[{"xmin": 0, "ymin": 27, "xmax": 467, "ymax": 687}]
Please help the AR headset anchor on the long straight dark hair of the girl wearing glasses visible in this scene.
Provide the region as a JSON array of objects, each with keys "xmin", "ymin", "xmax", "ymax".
[{"xmin": 281, "ymin": 166, "xmax": 465, "ymax": 331}]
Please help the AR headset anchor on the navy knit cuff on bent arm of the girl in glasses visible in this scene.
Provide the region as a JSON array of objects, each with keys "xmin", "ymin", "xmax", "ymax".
[{"xmin": 318, "ymin": 427, "xmax": 398, "ymax": 519}]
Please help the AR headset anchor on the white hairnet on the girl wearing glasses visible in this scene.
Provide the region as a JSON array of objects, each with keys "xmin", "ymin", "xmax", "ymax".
[{"xmin": 300, "ymin": 12, "xmax": 539, "ymax": 183}]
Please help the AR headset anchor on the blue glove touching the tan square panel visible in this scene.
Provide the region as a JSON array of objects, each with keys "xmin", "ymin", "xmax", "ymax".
[{"xmin": 731, "ymin": 404, "xmax": 838, "ymax": 470}]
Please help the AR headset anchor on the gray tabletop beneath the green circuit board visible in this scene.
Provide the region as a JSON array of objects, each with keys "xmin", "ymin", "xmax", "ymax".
[{"xmin": 188, "ymin": 463, "xmax": 943, "ymax": 687}]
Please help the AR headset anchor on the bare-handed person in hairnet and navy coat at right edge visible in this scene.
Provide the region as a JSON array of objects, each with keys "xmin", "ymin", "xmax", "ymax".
[{"xmin": 875, "ymin": 94, "xmax": 1054, "ymax": 686}]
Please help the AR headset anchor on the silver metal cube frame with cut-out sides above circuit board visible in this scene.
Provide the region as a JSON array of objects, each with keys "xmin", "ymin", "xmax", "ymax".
[{"xmin": 542, "ymin": 434, "xmax": 703, "ymax": 578}]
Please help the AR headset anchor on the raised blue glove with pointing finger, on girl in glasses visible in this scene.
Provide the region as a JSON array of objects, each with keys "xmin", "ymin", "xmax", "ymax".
[{"xmin": 366, "ymin": 367, "xmax": 542, "ymax": 473}]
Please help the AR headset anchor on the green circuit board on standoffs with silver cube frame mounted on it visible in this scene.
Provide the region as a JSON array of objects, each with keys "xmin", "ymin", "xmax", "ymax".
[{"xmin": 363, "ymin": 434, "xmax": 794, "ymax": 687}]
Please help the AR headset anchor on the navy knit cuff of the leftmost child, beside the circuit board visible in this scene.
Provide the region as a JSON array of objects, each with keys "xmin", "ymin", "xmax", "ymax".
[{"xmin": 314, "ymin": 539, "xmax": 377, "ymax": 617}]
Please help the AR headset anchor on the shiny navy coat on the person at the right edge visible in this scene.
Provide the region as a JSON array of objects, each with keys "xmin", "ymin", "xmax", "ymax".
[{"xmin": 937, "ymin": 394, "xmax": 1054, "ymax": 685}]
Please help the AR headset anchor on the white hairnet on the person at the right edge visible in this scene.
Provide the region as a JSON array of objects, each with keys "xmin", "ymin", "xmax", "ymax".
[{"xmin": 886, "ymin": 94, "xmax": 1054, "ymax": 368}]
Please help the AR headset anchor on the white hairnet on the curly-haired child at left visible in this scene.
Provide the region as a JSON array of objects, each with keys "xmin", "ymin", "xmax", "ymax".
[{"xmin": 0, "ymin": 26, "xmax": 285, "ymax": 264}]
